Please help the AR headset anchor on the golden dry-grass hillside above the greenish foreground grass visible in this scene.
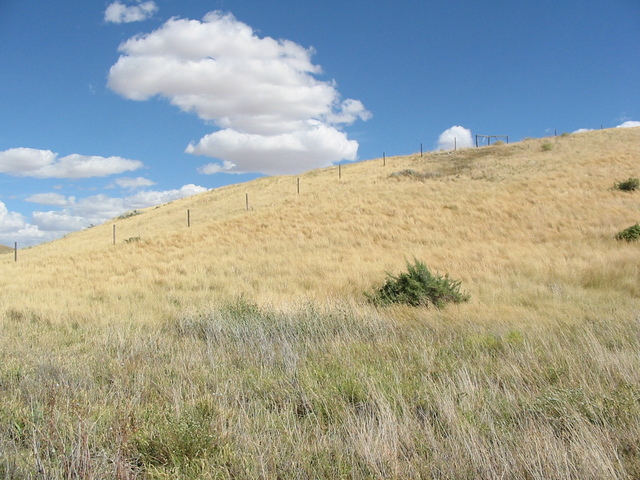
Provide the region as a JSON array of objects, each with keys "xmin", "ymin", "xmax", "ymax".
[{"xmin": 0, "ymin": 128, "xmax": 640, "ymax": 321}]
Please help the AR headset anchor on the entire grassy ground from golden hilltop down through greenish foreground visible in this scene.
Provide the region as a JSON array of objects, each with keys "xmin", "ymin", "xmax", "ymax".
[{"xmin": 0, "ymin": 128, "xmax": 640, "ymax": 479}]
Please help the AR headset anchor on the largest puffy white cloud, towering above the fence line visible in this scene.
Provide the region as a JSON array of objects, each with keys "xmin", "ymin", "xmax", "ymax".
[{"xmin": 109, "ymin": 12, "xmax": 371, "ymax": 173}]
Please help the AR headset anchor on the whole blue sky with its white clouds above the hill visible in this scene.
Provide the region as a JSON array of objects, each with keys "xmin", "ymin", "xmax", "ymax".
[{"xmin": 0, "ymin": 0, "xmax": 640, "ymax": 246}]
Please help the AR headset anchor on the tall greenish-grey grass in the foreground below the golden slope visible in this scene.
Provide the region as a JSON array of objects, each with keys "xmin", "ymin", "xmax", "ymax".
[{"xmin": 0, "ymin": 302, "xmax": 640, "ymax": 479}]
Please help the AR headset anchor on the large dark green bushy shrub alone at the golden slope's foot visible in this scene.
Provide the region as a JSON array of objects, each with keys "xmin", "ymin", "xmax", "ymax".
[{"xmin": 365, "ymin": 260, "xmax": 469, "ymax": 308}]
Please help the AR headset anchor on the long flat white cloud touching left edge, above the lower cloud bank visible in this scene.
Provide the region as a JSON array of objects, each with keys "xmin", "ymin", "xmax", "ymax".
[{"xmin": 0, "ymin": 147, "xmax": 143, "ymax": 178}]
